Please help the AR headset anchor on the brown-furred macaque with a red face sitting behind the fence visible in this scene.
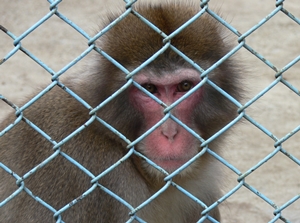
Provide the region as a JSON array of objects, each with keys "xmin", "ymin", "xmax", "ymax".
[{"xmin": 0, "ymin": 1, "xmax": 241, "ymax": 223}]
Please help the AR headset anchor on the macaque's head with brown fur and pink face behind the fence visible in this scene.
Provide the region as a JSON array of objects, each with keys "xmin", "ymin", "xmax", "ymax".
[{"xmin": 89, "ymin": 3, "xmax": 240, "ymax": 179}]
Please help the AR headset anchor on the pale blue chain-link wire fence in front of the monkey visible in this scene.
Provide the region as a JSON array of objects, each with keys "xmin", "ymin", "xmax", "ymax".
[{"xmin": 0, "ymin": 0, "xmax": 300, "ymax": 222}]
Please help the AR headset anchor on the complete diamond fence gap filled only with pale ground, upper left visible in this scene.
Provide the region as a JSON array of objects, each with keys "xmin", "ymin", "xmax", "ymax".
[{"xmin": 21, "ymin": 15, "xmax": 88, "ymax": 72}]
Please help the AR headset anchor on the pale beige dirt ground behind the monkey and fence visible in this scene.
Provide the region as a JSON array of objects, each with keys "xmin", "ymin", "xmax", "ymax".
[{"xmin": 0, "ymin": 0, "xmax": 300, "ymax": 223}]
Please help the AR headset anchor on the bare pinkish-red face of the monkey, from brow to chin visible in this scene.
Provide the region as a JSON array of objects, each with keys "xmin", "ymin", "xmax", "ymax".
[{"xmin": 130, "ymin": 69, "xmax": 202, "ymax": 172}]
